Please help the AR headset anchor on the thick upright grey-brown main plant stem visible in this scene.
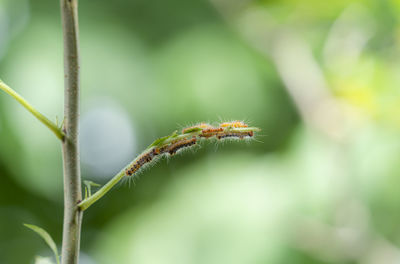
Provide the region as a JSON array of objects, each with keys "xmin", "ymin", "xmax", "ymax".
[{"xmin": 60, "ymin": 0, "xmax": 82, "ymax": 264}]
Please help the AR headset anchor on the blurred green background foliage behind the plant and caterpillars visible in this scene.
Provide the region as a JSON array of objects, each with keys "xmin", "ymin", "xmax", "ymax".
[{"xmin": 0, "ymin": 0, "xmax": 400, "ymax": 264}]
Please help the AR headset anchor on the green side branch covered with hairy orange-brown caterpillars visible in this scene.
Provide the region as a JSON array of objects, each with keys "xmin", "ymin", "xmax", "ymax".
[{"xmin": 78, "ymin": 121, "xmax": 261, "ymax": 211}]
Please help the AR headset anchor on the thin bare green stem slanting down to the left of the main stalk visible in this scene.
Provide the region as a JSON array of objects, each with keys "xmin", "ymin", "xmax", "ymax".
[{"xmin": 0, "ymin": 80, "xmax": 65, "ymax": 140}]
